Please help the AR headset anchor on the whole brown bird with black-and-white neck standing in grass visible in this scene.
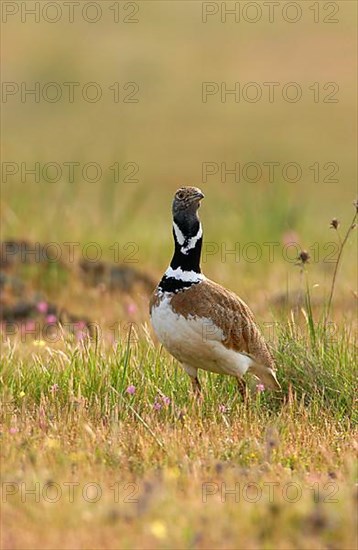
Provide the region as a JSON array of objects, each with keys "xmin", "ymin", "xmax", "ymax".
[{"xmin": 150, "ymin": 188, "xmax": 280, "ymax": 393}]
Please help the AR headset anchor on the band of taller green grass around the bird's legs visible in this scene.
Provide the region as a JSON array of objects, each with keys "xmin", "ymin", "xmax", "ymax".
[{"xmin": 2, "ymin": 312, "xmax": 356, "ymax": 418}]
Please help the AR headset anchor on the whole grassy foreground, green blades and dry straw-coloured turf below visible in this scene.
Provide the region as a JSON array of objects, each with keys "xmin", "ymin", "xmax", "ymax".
[{"xmin": 1, "ymin": 312, "xmax": 356, "ymax": 549}]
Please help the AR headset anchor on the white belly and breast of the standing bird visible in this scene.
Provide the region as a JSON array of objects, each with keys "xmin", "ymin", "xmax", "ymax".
[{"xmin": 151, "ymin": 296, "xmax": 252, "ymax": 376}]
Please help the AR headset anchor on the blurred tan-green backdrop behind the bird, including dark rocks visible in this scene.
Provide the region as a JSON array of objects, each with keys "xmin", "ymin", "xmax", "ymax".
[{"xmin": 1, "ymin": 0, "xmax": 357, "ymax": 336}]
